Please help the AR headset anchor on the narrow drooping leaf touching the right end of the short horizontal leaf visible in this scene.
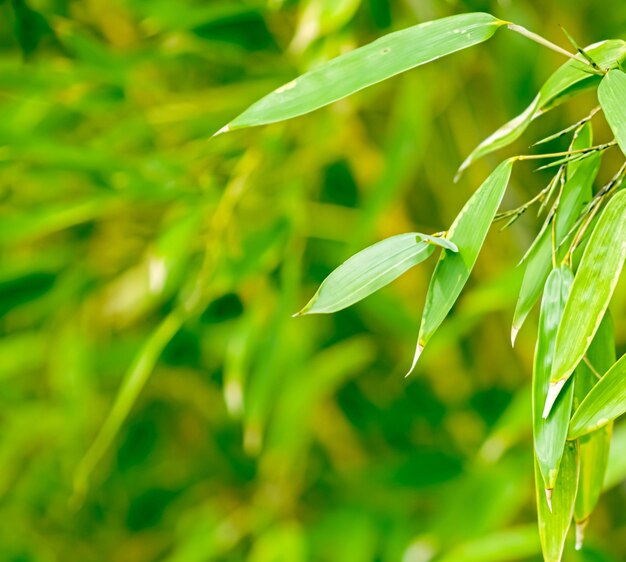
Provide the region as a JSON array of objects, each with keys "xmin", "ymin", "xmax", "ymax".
[{"xmin": 407, "ymin": 159, "xmax": 514, "ymax": 375}]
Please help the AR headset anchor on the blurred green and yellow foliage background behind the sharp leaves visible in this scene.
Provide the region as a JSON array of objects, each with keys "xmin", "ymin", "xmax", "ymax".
[{"xmin": 0, "ymin": 0, "xmax": 626, "ymax": 562}]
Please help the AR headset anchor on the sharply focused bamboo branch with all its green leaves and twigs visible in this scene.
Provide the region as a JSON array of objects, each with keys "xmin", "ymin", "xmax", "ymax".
[{"xmin": 217, "ymin": 13, "xmax": 626, "ymax": 562}]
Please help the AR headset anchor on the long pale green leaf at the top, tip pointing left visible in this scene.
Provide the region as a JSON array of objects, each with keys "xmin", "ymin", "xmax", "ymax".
[{"xmin": 219, "ymin": 13, "xmax": 505, "ymax": 132}]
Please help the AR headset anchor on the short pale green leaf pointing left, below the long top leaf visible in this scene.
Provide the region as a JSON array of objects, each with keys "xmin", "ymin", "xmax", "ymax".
[{"xmin": 296, "ymin": 232, "xmax": 458, "ymax": 316}]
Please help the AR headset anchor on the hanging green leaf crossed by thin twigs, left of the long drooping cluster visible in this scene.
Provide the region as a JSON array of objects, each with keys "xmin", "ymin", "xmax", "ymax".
[{"xmin": 511, "ymin": 123, "xmax": 601, "ymax": 343}]
